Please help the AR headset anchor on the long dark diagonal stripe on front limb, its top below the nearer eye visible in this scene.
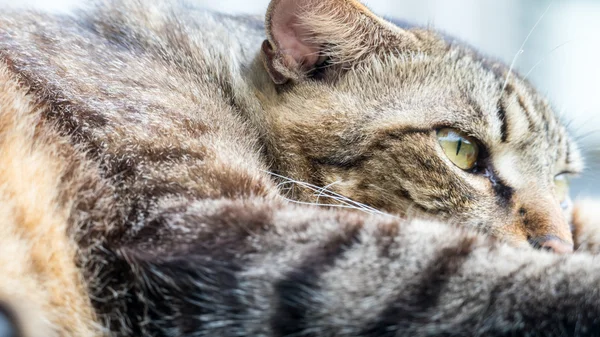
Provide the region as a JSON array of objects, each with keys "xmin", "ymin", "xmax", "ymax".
[{"xmin": 359, "ymin": 237, "xmax": 475, "ymax": 337}]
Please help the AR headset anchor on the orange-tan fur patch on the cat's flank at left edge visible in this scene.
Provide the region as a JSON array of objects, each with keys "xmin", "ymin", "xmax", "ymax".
[{"xmin": 0, "ymin": 64, "xmax": 101, "ymax": 337}]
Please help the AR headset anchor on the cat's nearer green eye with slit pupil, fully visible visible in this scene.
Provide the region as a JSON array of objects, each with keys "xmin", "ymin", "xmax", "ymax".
[{"xmin": 437, "ymin": 128, "xmax": 479, "ymax": 171}]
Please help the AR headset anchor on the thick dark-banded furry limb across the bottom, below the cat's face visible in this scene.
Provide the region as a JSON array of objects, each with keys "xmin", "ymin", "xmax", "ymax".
[{"xmin": 86, "ymin": 200, "xmax": 600, "ymax": 337}]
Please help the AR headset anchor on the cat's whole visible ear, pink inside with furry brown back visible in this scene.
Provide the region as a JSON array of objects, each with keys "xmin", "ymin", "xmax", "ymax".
[{"xmin": 262, "ymin": 0, "xmax": 408, "ymax": 84}]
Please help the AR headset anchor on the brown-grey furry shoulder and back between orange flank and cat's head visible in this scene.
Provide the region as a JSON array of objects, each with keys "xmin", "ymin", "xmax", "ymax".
[{"xmin": 0, "ymin": 1, "xmax": 274, "ymax": 220}]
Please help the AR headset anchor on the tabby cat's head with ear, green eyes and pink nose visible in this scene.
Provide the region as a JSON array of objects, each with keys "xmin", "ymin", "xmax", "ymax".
[{"xmin": 254, "ymin": 0, "xmax": 582, "ymax": 252}]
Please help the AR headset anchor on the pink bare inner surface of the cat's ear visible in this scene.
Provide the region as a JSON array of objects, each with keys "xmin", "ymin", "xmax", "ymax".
[{"xmin": 271, "ymin": 0, "xmax": 319, "ymax": 70}]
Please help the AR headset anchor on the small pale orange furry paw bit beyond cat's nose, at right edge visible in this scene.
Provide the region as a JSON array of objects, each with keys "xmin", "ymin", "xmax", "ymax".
[{"xmin": 572, "ymin": 200, "xmax": 600, "ymax": 254}]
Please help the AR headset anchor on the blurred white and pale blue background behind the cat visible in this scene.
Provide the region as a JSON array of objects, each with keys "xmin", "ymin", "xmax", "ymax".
[{"xmin": 0, "ymin": 0, "xmax": 600, "ymax": 196}]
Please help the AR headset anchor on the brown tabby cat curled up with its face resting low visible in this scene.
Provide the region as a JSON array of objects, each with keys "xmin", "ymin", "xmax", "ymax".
[{"xmin": 0, "ymin": 0, "xmax": 600, "ymax": 337}]
